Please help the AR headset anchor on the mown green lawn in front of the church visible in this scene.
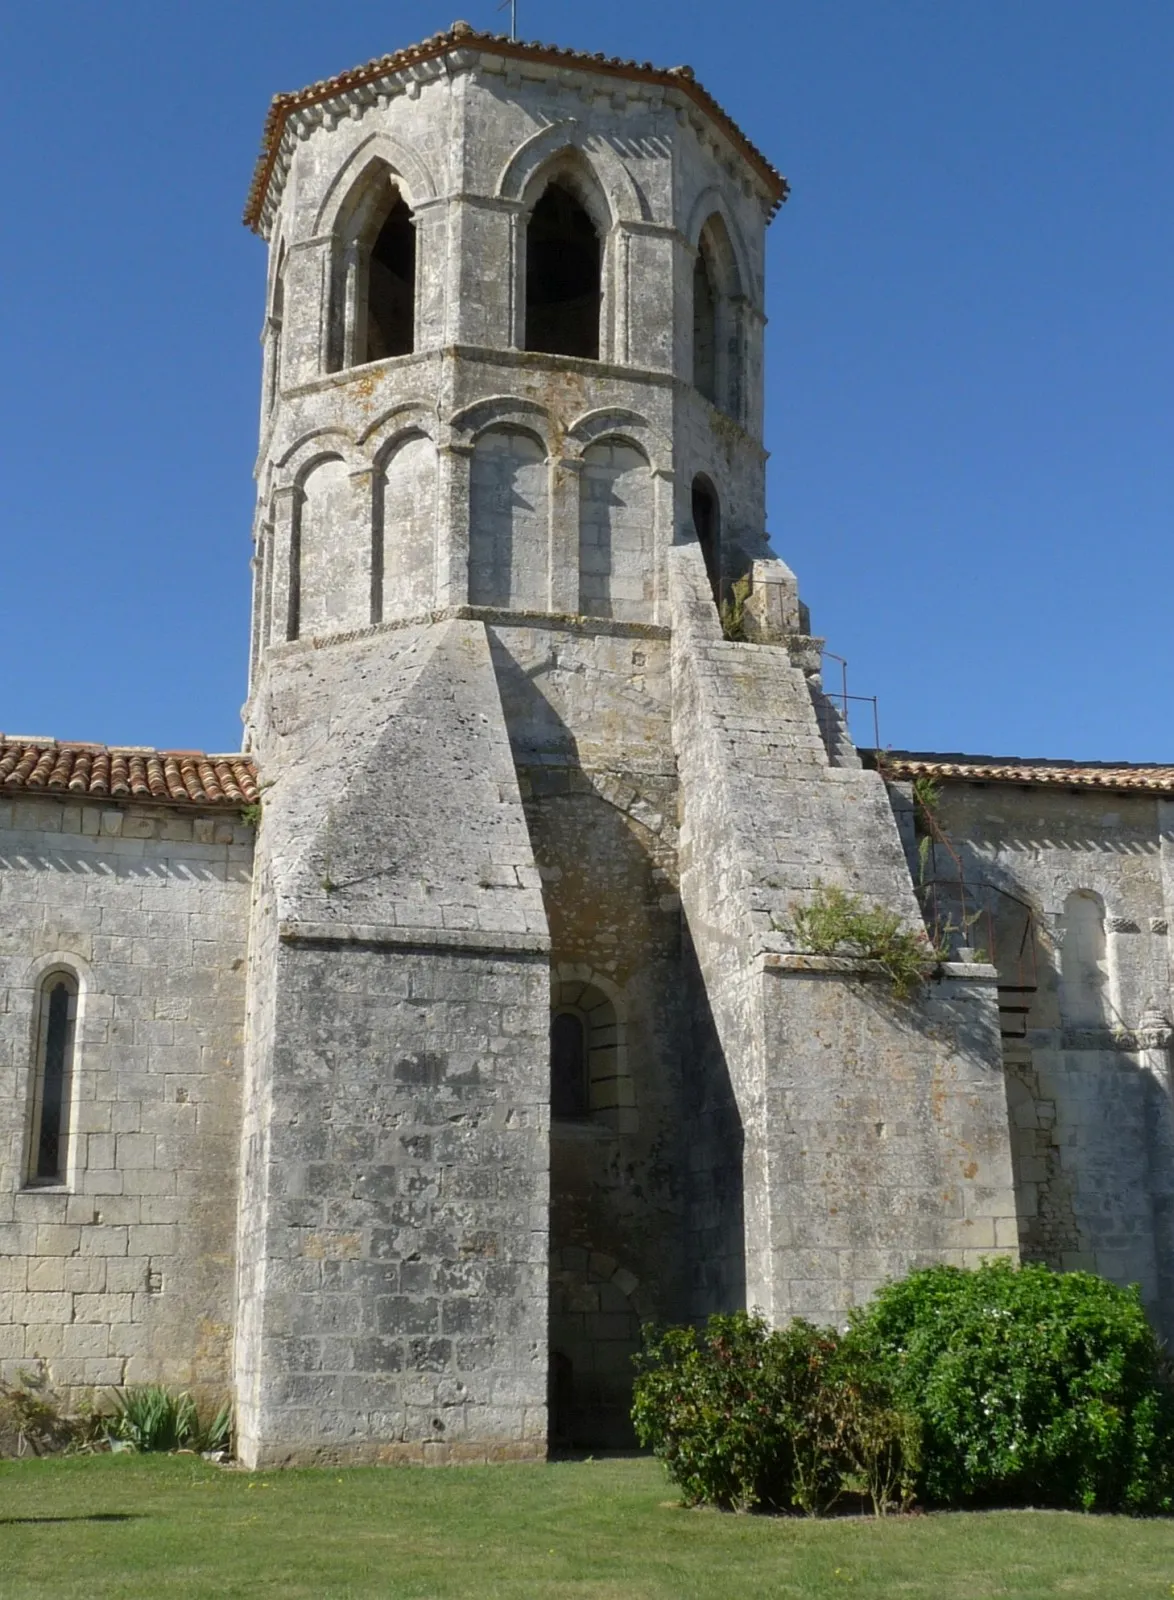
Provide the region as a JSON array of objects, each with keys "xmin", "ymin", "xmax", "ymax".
[{"xmin": 0, "ymin": 1456, "xmax": 1174, "ymax": 1600}]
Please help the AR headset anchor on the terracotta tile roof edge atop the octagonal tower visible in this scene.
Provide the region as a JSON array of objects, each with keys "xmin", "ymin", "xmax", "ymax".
[{"xmin": 245, "ymin": 22, "xmax": 789, "ymax": 230}]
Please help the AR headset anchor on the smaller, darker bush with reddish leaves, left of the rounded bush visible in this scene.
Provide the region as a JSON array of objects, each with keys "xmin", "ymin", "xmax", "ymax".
[{"xmin": 632, "ymin": 1312, "xmax": 918, "ymax": 1515}]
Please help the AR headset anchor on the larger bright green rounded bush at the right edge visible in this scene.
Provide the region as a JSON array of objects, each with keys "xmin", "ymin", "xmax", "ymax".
[{"xmin": 848, "ymin": 1261, "xmax": 1174, "ymax": 1512}]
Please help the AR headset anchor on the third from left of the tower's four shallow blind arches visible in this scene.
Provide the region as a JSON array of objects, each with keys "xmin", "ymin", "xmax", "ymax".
[{"xmin": 469, "ymin": 427, "xmax": 550, "ymax": 611}]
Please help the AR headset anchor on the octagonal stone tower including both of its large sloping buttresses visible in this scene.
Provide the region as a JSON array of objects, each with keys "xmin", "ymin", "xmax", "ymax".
[{"xmin": 235, "ymin": 22, "xmax": 1014, "ymax": 1464}]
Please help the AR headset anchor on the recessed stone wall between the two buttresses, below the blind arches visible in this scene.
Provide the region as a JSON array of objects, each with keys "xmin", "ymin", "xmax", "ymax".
[{"xmin": 491, "ymin": 619, "xmax": 689, "ymax": 1448}]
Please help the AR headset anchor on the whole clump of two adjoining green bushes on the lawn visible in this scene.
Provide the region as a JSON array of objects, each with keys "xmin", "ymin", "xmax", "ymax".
[{"xmin": 632, "ymin": 1261, "xmax": 1174, "ymax": 1515}]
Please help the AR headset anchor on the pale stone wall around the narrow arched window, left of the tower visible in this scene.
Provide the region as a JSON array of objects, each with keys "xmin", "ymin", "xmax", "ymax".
[{"xmin": 0, "ymin": 797, "xmax": 253, "ymax": 1394}]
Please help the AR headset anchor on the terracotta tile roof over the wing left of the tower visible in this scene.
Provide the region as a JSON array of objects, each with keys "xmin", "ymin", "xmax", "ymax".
[{"xmin": 0, "ymin": 733, "xmax": 258, "ymax": 808}]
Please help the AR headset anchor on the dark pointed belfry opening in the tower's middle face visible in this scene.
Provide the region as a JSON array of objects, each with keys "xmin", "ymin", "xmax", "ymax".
[{"xmin": 526, "ymin": 184, "xmax": 601, "ymax": 362}]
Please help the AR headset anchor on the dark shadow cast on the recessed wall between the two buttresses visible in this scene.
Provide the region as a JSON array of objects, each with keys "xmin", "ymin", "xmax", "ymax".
[{"xmin": 489, "ymin": 629, "xmax": 703, "ymax": 1450}]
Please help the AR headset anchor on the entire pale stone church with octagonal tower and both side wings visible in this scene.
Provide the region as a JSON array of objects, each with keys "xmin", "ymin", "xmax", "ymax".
[{"xmin": 0, "ymin": 22, "xmax": 1174, "ymax": 1466}]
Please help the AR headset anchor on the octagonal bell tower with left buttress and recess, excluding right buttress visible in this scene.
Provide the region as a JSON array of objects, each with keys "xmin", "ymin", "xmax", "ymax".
[{"xmin": 237, "ymin": 22, "xmax": 785, "ymax": 1464}]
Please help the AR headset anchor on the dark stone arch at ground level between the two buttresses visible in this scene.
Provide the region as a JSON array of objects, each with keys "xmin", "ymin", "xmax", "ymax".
[{"xmin": 549, "ymin": 1245, "xmax": 651, "ymax": 1450}]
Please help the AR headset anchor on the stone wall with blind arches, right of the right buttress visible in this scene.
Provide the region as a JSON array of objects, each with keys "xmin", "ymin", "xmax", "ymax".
[{"xmin": 900, "ymin": 782, "xmax": 1174, "ymax": 1334}]
